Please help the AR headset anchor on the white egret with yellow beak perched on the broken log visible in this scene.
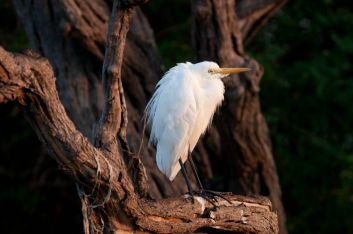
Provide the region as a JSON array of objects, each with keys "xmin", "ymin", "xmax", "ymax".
[{"xmin": 145, "ymin": 61, "xmax": 250, "ymax": 204}]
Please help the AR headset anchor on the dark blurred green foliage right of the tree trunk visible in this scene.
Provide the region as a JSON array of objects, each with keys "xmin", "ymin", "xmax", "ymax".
[{"xmin": 246, "ymin": 0, "xmax": 353, "ymax": 233}]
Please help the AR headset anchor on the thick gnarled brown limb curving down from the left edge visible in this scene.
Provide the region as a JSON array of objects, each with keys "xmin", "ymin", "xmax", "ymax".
[{"xmin": 0, "ymin": 45, "xmax": 142, "ymax": 230}]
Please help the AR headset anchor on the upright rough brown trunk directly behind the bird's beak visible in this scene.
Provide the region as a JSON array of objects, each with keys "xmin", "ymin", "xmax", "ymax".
[{"xmin": 192, "ymin": 0, "xmax": 286, "ymax": 233}]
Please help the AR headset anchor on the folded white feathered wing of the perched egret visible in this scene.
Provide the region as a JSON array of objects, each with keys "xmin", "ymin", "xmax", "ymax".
[{"xmin": 147, "ymin": 65, "xmax": 199, "ymax": 180}]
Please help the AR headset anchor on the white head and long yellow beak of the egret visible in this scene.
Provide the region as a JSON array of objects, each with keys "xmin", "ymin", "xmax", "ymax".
[{"xmin": 189, "ymin": 61, "xmax": 251, "ymax": 79}]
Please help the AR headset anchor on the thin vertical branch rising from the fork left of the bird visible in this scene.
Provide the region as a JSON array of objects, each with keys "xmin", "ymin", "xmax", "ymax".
[{"xmin": 95, "ymin": 1, "xmax": 133, "ymax": 147}]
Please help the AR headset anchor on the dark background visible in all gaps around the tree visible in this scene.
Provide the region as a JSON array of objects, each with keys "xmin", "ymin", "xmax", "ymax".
[{"xmin": 0, "ymin": 0, "xmax": 353, "ymax": 234}]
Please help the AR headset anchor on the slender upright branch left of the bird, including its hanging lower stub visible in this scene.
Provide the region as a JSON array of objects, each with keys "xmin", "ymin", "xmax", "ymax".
[{"xmin": 93, "ymin": 1, "xmax": 148, "ymax": 196}]
